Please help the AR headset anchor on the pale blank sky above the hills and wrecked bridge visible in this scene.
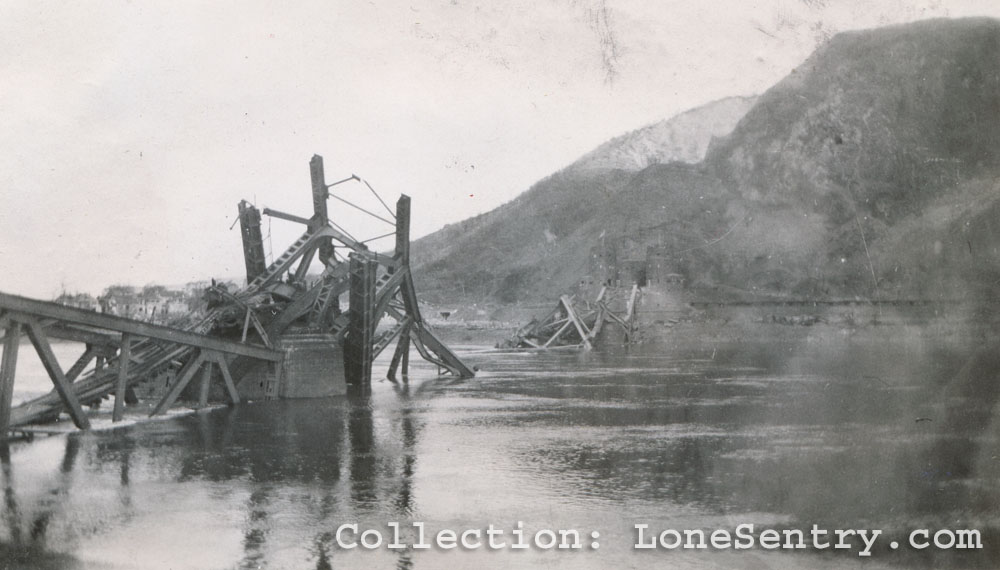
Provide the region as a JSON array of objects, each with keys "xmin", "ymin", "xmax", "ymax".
[{"xmin": 0, "ymin": 0, "xmax": 1000, "ymax": 298}]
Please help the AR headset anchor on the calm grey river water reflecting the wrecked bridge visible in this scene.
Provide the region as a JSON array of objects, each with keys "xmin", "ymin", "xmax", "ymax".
[{"xmin": 0, "ymin": 327, "xmax": 1000, "ymax": 570}]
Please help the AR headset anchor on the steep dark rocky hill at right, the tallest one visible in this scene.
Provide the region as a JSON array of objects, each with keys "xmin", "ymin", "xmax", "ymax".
[{"xmin": 702, "ymin": 19, "xmax": 1000, "ymax": 298}]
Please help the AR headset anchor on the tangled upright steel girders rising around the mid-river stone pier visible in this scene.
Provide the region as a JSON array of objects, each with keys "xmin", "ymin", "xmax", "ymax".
[{"xmin": 236, "ymin": 156, "xmax": 475, "ymax": 390}]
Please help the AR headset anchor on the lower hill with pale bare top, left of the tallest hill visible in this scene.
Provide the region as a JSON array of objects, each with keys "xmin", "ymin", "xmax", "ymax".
[{"xmin": 412, "ymin": 97, "xmax": 753, "ymax": 303}]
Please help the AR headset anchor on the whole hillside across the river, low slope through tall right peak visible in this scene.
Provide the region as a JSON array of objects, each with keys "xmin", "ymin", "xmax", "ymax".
[{"xmin": 414, "ymin": 19, "xmax": 1000, "ymax": 302}]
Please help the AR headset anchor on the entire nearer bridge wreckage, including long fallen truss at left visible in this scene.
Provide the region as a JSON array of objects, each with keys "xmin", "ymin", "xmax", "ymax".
[{"xmin": 0, "ymin": 156, "xmax": 474, "ymax": 439}]
